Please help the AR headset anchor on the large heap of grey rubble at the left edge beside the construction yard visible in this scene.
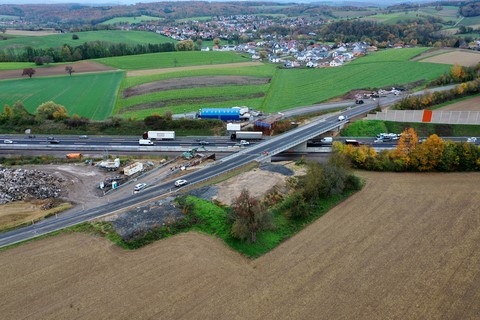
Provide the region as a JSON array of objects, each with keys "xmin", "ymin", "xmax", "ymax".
[{"xmin": 0, "ymin": 166, "xmax": 66, "ymax": 204}]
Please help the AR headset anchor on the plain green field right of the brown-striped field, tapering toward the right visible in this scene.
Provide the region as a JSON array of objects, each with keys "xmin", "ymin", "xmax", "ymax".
[{"xmin": 262, "ymin": 61, "xmax": 450, "ymax": 112}]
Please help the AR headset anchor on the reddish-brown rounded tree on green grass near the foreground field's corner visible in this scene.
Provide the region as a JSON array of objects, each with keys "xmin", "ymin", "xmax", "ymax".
[{"xmin": 231, "ymin": 189, "xmax": 272, "ymax": 243}]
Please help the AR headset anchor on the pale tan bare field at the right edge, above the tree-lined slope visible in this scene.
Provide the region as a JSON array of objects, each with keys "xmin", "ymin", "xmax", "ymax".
[{"xmin": 413, "ymin": 49, "xmax": 480, "ymax": 67}]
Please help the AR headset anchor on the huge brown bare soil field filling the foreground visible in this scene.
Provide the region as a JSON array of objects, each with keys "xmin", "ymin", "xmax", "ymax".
[{"xmin": 0, "ymin": 172, "xmax": 480, "ymax": 319}]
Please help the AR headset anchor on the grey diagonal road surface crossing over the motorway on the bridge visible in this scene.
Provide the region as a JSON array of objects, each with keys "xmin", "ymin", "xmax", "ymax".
[{"xmin": 0, "ymin": 100, "xmax": 376, "ymax": 247}]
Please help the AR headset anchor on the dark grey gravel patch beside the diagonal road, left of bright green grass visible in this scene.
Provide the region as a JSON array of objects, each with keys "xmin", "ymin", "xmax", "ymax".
[{"xmin": 112, "ymin": 197, "xmax": 183, "ymax": 240}]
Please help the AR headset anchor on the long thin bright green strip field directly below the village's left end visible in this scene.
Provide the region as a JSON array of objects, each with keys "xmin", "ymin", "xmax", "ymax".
[{"xmin": 95, "ymin": 51, "xmax": 251, "ymax": 70}]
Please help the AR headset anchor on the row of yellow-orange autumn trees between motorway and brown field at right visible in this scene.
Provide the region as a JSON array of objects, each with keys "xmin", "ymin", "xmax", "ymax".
[{"xmin": 333, "ymin": 128, "xmax": 480, "ymax": 172}]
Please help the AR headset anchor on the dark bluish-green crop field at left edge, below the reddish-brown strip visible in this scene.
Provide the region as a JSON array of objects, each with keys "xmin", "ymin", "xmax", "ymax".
[{"xmin": 0, "ymin": 72, "xmax": 123, "ymax": 120}]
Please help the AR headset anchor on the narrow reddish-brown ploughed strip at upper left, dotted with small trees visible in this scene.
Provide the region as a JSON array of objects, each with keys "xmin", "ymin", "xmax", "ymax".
[{"xmin": 0, "ymin": 61, "xmax": 115, "ymax": 80}]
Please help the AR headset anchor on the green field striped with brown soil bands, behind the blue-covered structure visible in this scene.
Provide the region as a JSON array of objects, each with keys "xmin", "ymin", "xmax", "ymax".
[{"xmin": 115, "ymin": 63, "xmax": 275, "ymax": 118}]
